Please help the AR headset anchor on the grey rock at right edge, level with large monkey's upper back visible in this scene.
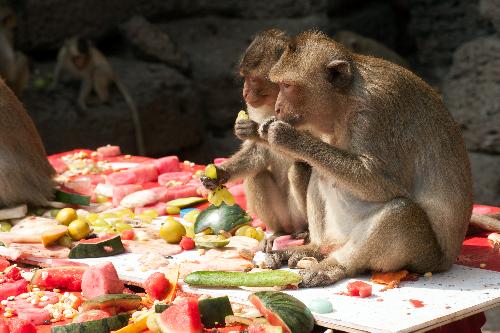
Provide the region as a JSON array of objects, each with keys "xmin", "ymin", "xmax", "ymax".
[{"xmin": 443, "ymin": 36, "xmax": 500, "ymax": 153}]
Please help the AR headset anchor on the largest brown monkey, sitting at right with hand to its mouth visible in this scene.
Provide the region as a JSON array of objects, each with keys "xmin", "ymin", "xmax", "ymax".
[{"xmin": 259, "ymin": 32, "xmax": 472, "ymax": 286}]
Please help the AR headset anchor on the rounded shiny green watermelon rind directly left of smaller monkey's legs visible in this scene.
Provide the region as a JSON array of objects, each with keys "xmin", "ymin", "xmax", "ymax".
[{"xmin": 194, "ymin": 203, "xmax": 252, "ymax": 234}]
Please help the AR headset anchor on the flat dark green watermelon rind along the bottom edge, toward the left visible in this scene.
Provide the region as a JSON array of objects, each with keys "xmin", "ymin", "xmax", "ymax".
[{"xmin": 51, "ymin": 313, "xmax": 130, "ymax": 333}]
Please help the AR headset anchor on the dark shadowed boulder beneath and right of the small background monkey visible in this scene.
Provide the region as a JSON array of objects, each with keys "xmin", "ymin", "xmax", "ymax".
[{"xmin": 23, "ymin": 58, "xmax": 204, "ymax": 156}]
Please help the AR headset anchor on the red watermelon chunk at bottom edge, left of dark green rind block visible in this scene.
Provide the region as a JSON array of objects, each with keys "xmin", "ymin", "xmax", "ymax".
[{"xmin": 158, "ymin": 297, "xmax": 203, "ymax": 333}]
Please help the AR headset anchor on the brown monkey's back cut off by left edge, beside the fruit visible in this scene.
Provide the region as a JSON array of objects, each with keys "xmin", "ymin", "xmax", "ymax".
[{"xmin": 0, "ymin": 79, "xmax": 55, "ymax": 208}]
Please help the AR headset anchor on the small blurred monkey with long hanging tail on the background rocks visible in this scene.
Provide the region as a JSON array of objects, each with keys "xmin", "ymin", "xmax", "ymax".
[{"xmin": 51, "ymin": 37, "xmax": 146, "ymax": 155}]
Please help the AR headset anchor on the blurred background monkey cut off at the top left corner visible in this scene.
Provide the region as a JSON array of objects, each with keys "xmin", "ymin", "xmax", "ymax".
[{"xmin": 0, "ymin": 2, "xmax": 30, "ymax": 96}]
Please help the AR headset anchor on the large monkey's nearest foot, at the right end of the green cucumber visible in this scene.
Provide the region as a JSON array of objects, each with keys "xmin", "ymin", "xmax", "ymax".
[{"xmin": 299, "ymin": 260, "xmax": 347, "ymax": 288}]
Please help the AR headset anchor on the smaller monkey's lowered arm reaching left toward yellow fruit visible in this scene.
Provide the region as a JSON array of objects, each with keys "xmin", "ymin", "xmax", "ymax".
[{"xmin": 201, "ymin": 140, "xmax": 269, "ymax": 190}]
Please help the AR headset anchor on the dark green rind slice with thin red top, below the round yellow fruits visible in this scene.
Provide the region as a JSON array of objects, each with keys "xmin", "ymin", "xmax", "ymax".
[{"xmin": 68, "ymin": 235, "xmax": 125, "ymax": 259}]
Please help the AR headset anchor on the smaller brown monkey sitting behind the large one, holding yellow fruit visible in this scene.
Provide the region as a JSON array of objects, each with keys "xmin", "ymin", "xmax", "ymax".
[{"xmin": 203, "ymin": 29, "xmax": 310, "ymax": 251}]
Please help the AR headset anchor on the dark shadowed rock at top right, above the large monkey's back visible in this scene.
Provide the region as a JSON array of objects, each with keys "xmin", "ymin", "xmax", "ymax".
[{"xmin": 408, "ymin": 0, "xmax": 493, "ymax": 81}]
